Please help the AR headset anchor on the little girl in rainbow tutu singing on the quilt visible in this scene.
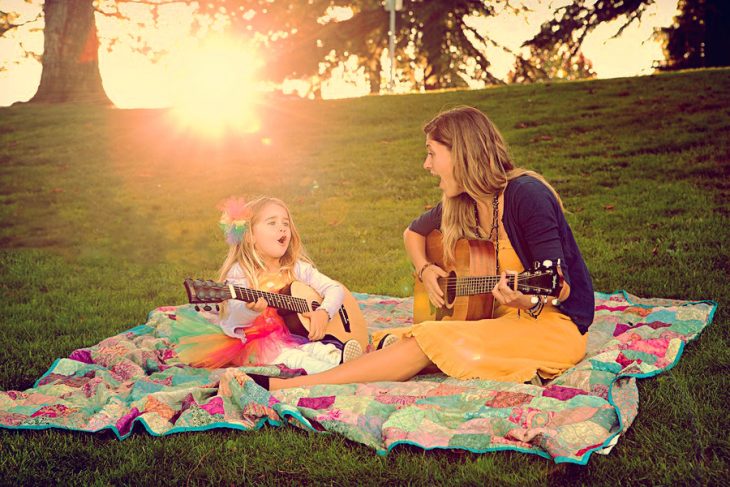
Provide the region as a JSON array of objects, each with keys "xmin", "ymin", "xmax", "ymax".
[{"xmin": 173, "ymin": 197, "xmax": 362, "ymax": 374}]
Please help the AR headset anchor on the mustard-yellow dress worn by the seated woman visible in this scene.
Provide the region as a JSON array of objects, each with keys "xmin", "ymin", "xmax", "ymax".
[{"xmin": 373, "ymin": 232, "xmax": 586, "ymax": 382}]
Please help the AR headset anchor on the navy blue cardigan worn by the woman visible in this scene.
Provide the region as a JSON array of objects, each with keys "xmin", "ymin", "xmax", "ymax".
[{"xmin": 408, "ymin": 176, "xmax": 595, "ymax": 333}]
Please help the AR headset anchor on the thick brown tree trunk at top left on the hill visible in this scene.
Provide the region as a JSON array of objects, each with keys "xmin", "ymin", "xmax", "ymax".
[{"xmin": 30, "ymin": 0, "xmax": 112, "ymax": 105}]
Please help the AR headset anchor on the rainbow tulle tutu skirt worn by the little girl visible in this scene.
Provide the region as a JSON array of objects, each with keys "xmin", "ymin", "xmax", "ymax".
[{"xmin": 172, "ymin": 307, "xmax": 308, "ymax": 369}]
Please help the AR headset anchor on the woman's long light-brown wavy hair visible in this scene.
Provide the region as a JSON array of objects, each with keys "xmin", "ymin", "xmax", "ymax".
[{"xmin": 423, "ymin": 106, "xmax": 563, "ymax": 262}]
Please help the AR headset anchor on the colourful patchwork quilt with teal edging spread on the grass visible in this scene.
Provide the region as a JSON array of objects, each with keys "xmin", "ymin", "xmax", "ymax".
[{"xmin": 0, "ymin": 292, "xmax": 717, "ymax": 464}]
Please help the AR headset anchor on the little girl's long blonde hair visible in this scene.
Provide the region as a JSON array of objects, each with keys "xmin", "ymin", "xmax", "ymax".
[{"xmin": 219, "ymin": 196, "xmax": 312, "ymax": 288}]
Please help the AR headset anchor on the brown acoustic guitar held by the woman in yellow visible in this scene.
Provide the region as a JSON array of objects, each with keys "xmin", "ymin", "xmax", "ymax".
[{"xmin": 413, "ymin": 230, "xmax": 562, "ymax": 323}]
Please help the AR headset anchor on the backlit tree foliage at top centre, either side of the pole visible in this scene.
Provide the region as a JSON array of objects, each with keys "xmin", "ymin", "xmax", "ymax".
[{"xmin": 191, "ymin": 0, "xmax": 509, "ymax": 93}]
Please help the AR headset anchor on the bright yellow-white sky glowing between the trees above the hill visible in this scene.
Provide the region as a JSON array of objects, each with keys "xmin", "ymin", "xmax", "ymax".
[{"xmin": 0, "ymin": 0, "xmax": 677, "ymax": 107}]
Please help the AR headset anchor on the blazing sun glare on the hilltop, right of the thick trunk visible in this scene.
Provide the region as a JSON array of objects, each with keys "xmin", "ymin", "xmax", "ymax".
[{"xmin": 171, "ymin": 38, "xmax": 263, "ymax": 137}]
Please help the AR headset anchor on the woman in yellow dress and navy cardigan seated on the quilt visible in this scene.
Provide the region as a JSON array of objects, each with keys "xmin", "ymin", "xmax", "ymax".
[{"xmin": 253, "ymin": 107, "xmax": 594, "ymax": 390}]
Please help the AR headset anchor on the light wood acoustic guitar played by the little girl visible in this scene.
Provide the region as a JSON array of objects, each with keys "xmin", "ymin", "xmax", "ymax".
[{"xmin": 184, "ymin": 278, "xmax": 368, "ymax": 350}]
